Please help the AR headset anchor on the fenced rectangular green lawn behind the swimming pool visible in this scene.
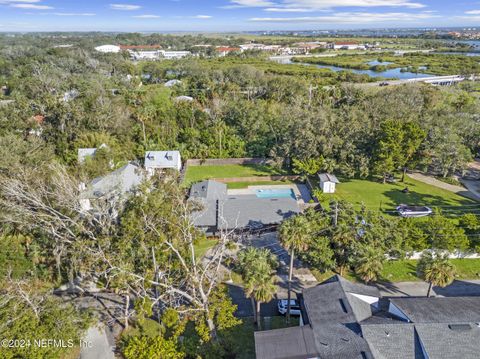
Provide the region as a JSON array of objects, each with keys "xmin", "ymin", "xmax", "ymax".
[{"xmin": 185, "ymin": 165, "xmax": 287, "ymax": 186}]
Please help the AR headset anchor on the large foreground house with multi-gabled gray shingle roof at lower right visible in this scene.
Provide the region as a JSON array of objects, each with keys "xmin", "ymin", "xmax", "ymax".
[{"xmin": 255, "ymin": 275, "xmax": 480, "ymax": 359}]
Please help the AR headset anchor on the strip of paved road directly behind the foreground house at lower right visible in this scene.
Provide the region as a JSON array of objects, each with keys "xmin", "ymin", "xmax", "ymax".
[{"xmin": 377, "ymin": 280, "xmax": 480, "ymax": 297}]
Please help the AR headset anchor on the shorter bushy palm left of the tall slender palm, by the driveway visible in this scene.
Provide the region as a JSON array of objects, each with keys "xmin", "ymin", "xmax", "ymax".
[{"xmin": 245, "ymin": 263, "xmax": 276, "ymax": 330}]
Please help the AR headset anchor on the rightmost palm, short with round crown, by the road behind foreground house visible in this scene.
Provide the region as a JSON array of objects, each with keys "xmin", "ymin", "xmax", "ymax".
[{"xmin": 417, "ymin": 252, "xmax": 455, "ymax": 297}]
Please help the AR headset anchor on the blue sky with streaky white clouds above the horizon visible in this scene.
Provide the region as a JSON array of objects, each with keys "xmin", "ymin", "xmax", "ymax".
[{"xmin": 0, "ymin": 0, "xmax": 480, "ymax": 32}]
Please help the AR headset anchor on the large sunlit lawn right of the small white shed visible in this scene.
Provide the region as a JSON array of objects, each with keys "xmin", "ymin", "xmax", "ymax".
[{"xmin": 324, "ymin": 177, "xmax": 478, "ymax": 211}]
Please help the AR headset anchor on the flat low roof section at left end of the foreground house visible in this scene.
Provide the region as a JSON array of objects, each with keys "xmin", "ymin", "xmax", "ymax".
[{"xmin": 255, "ymin": 326, "xmax": 318, "ymax": 359}]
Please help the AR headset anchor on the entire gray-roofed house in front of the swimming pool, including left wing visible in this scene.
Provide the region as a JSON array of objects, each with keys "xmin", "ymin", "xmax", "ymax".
[{"xmin": 189, "ymin": 180, "xmax": 300, "ymax": 235}]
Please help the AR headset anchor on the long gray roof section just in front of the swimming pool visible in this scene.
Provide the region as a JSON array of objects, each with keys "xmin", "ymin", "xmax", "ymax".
[{"xmin": 218, "ymin": 195, "xmax": 300, "ymax": 229}]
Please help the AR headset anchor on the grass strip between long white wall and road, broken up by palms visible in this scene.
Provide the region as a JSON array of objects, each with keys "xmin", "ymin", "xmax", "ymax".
[{"xmin": 312, "ymin": 259, "xmax": 480, "ymax": 282}]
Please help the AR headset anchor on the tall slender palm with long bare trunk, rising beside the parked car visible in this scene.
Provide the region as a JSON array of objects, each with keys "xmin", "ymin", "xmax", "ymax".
[{"xmin": 279, "ymin": 216, "xmax": 311, "ymax": 323}]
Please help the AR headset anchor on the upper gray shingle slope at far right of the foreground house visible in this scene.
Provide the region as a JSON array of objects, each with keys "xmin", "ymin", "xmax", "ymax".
[{"xmin": 390, "ymin": 297, "xmax": 480, "ymax": 323}]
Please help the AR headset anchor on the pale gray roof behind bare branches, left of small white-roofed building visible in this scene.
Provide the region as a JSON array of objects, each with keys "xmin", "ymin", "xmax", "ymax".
[{"xmin": 82, "ymin": 163, "xmax": 145, "ymax": 198}]
